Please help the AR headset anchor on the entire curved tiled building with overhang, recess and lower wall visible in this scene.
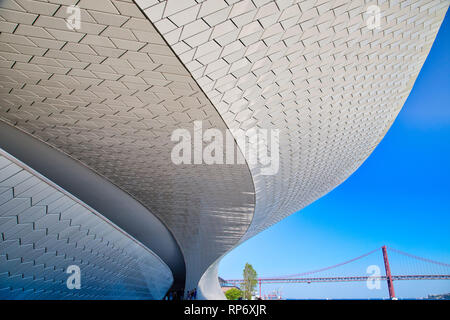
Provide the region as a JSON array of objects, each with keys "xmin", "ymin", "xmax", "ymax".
[{"xmin": 0, "ymin": 0, "xmax": 449, "ymax": 299}]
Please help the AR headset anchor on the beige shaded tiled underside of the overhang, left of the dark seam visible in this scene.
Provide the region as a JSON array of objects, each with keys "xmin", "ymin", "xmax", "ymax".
[{"xmin": 0, "ymin": 0, "xmax": 254, "ymax": 289}]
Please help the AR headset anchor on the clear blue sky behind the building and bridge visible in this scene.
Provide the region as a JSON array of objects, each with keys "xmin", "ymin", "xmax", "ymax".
[{"xmin": 219, "ymin": 13, "xmax": 450, "ymax": 298}]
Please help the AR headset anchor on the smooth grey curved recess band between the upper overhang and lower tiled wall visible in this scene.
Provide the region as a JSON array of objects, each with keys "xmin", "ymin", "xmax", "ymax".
[{"xmin": 0, "ymin": 121, "xmax": 186, "ymax": 288}]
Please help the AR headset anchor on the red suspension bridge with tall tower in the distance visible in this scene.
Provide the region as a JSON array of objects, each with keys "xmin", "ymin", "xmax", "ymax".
[{"xmin": 225, "ymin": 246, "xmax": 450, "ymax": 299}]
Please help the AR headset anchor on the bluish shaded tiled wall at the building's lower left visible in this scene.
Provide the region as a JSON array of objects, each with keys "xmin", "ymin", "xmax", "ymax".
[{"xmin": 0, "ymin": 149, "xmax": 173, "ymax": 299}]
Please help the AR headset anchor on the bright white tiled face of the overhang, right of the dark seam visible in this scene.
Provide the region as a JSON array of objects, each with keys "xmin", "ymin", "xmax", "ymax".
[{"xmin": 136, "ymin": 0, "xmax": 450, "ymax": 262}]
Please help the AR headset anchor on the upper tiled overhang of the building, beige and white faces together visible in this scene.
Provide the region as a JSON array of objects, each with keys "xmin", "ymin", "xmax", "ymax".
[{"xmin": 0, "ymin": 0, "xmax": 449, "ymax": 298}]
